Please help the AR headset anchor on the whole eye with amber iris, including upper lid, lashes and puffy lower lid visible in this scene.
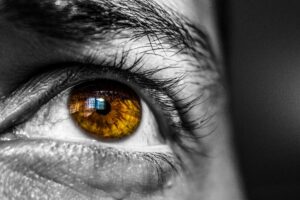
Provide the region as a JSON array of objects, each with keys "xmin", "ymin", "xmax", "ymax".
[{"xmin": 1, "ymin": 53, "xmax": 206, "ymax": 196}]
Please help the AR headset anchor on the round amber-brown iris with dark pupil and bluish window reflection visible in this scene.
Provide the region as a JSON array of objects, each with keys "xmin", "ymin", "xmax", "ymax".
[{"xmin": 69, "ymin": 80, "xmax": 142, "ymax": 139}]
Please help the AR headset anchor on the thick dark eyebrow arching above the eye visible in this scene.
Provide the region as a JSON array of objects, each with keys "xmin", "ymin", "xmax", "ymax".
[{"xmin": 0, "ymin": 0, "xmax": 214, "ymax": 68}]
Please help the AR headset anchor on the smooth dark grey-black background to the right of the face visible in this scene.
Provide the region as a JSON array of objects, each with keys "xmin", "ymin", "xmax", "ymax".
[{"xmin": 225, "ymin": 0, "xmax": 300, "ymax": 200}]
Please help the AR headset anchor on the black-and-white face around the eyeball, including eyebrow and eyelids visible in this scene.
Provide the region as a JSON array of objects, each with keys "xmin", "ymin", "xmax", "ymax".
[{"xmin": 0, "ymin": 0, "xmax": 243, "ymax": 200}]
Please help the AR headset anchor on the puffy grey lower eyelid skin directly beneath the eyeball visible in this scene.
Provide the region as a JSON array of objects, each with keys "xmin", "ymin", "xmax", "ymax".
[{"xmin": 0, "ymin": 140, "xmax": 179, "ymax": 193}]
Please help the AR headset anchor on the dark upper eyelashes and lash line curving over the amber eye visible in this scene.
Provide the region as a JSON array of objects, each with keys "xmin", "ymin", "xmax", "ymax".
[{"xmin": 0, "ymin": 53, "xmax": 202, "ymax": 151}]
